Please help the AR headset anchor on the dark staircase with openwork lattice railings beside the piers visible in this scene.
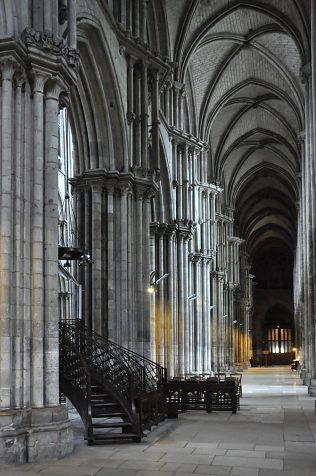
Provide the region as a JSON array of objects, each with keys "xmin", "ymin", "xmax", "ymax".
[{"xmin": 59, "ymin": 320, "xmax": 166, "ymax": 445}]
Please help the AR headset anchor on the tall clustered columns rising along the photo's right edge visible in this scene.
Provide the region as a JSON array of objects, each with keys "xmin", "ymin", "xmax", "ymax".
[{"xmin": 294, "ymin": 2, "xmax": 316, "ymax": 395}]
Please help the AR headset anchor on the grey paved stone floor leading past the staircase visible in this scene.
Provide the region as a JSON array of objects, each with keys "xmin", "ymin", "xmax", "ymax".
[{"xmin": 0, "ymin": 367, "xmax": 316, "ymax": 476}]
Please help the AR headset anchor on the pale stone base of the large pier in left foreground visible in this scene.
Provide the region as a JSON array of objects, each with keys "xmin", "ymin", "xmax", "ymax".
[{"xmin": 0, "ymin": 405, "xmax": 73, "ymax": 466}]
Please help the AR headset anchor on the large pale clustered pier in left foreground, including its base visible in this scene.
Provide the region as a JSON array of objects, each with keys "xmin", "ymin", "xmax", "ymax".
[{"xmin": 0, "ymin": 52, "xmax": 72, "ymax": 462}]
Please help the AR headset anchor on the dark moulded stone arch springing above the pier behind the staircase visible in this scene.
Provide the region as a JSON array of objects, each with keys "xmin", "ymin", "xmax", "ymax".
[{"xmin": 71, "ymin": 21, "xmax": 128, "ymax": 173}]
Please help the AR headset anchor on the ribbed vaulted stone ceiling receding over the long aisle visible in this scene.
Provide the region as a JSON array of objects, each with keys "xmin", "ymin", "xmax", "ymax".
[{"xmin": 169, "ymin": 0, "xmax": 309, "ymax": 362}]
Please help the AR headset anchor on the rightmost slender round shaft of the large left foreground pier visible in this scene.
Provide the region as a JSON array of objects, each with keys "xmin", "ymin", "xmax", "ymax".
[{"xmin": 42, "ymin": 80, "xmax": 64, "ymax": 406}]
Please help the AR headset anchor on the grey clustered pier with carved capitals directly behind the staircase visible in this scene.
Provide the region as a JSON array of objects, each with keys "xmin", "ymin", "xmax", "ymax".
[{"xmin": 71, "ymin": 167, "xmax": 156, "ymax": 356}]
